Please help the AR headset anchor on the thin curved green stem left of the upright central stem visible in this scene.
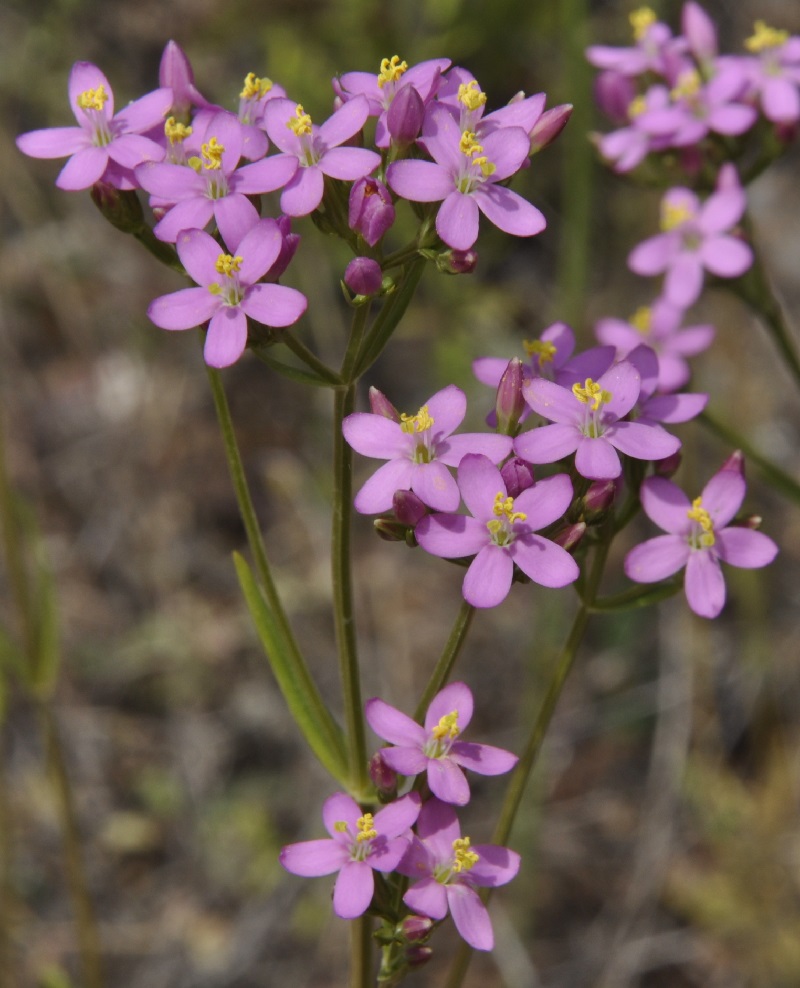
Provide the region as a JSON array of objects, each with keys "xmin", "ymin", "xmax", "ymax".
[{"xmin": 206, "ymin": 367, "xmax": 342, "ymax": 772}]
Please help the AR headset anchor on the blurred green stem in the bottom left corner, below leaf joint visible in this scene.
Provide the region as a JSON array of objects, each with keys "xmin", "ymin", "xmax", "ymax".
[{"xmin": 39, "ymin": 702, "xmax": 103, "ymax": 988}]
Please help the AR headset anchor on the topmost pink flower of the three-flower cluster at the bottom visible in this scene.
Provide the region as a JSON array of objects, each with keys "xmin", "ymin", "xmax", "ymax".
[{"xmin": 364, "ymin": 683, "xmax": 517, "ymax": 806}]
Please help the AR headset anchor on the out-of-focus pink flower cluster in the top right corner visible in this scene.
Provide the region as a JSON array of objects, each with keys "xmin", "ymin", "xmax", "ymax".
[{"xmin": 587, "ymin": 0, "xmax": 800, "ymax": 172}]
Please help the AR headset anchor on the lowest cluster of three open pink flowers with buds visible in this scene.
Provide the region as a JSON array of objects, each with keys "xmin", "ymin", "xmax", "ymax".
[{"xmin": 281, "ymin": 683, "xmax": 520, "ymax": 950}]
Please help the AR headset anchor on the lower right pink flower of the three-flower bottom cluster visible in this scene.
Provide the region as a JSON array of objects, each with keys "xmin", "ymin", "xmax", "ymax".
[{"xmin": 397, "ymin": 799, "xmax": 520, "ymax": 950}]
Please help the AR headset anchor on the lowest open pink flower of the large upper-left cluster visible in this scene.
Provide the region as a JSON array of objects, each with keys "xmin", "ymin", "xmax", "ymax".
[{"xmin": 147, "ymin": 219, "xmax": 308, "ymax": 367}]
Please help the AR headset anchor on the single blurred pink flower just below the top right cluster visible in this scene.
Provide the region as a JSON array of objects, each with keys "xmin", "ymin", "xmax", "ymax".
[{"xmin": 628, "ymin": 164, "xmax": 753, "ymax": 309}]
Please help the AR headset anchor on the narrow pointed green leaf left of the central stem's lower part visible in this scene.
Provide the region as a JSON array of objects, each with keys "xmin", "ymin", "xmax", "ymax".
[{"xmin": 233, "ymin": 552, "xmax": 348, "ymax": 786}]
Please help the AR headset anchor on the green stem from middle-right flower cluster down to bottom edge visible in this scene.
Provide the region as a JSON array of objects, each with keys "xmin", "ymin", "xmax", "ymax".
[{"xmin": 445, "ymin": 519, "xmax": 613, "ymax": 988}]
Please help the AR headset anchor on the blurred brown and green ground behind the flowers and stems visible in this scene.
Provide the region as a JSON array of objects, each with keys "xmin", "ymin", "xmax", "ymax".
[{"xmin": 0, "ymin": 0, "xmax": 800, "ymax": 988}]
